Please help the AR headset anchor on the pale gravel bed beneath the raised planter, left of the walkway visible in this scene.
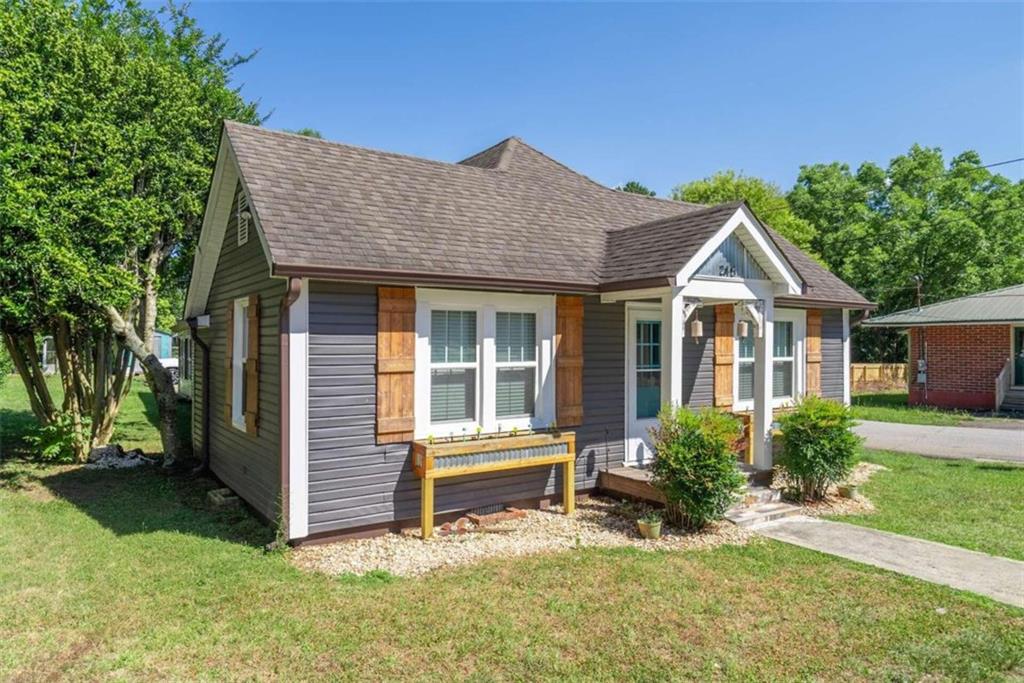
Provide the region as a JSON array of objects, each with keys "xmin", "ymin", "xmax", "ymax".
[{"xmin": 292, "ymin": 498, "xmax": 753, "ymax": 577}]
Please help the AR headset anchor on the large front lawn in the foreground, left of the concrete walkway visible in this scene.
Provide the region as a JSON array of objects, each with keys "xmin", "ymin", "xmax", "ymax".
[{"xmin": 0, "ymin": 462, "xmax": 1024, "ymax": 681}]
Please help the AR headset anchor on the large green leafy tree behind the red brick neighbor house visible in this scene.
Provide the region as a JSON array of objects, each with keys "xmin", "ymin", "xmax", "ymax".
[{"xmin": 788, "ymin": 145, "xmax": 1024, "ymax": 360}]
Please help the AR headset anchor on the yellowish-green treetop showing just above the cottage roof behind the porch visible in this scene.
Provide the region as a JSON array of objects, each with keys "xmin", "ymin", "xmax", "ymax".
[{"xmin": 672, "ymin": 171, "xmax": 815, "ymax": 254}]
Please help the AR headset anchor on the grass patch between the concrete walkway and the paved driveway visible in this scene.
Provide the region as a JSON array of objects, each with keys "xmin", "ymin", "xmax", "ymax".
[{"xmin": 837, "ymin": 451, "xmax": 1024, "ymax": 560}]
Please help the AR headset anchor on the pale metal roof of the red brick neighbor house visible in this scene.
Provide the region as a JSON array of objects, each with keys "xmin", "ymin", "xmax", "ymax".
[{"xmin": 862, "ymin": 284, "xmax": 1024, "ymax": 328}]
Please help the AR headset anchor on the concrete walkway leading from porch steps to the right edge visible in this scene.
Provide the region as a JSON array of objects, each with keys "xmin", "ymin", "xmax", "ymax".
[{"xmin": 752, "ymin": 515, "xmax": 1024, "ymax": 607}]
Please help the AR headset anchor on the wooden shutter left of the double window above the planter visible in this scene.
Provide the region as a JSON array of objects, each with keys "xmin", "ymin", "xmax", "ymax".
[{"xmin": 377, "ymin": 287, "xmax": 416, "ymax": 443}]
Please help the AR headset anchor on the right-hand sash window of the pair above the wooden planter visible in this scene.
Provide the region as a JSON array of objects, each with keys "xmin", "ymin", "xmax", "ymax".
[{"xmin": 495, "ymin": 311, "xmax": 537, "ymax": 418}]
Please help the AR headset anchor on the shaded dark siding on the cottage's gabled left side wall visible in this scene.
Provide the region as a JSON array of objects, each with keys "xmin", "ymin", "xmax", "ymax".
[{"xmin": 193, "ymin": 184, "xmax": 285, "ymax": 520}]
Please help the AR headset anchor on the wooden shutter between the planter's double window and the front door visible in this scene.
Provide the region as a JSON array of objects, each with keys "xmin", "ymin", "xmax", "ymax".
[{"xmin": 555, "ymin": 296, "xmax": 583, "ymax": 427}]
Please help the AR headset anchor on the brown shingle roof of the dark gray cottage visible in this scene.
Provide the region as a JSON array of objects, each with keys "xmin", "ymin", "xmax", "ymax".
[{"xmin": 230, "ymin": 122, "xmax": 872, "ymax": 307}]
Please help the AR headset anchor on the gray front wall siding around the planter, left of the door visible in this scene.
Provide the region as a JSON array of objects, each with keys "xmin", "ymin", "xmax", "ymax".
[{"xmin": 299, "ymin": 282, "xmax": 624, "ymax": 533}]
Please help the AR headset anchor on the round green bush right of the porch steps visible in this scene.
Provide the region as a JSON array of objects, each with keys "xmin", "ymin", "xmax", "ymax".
[{"xmin": 775, "ymin": 395, "xmax": 860, "ymax": 500}]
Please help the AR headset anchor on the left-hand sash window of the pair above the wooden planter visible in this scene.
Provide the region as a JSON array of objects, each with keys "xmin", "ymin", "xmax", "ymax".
[{"xmin": 430, "ymin": 310, "xmax": 477, "ymax": 423}]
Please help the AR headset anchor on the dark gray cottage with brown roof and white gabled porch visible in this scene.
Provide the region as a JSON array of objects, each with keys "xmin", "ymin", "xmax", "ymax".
[{"xmin": 185, "ymin": 122, "xmax": 871, "ymax": 542}]
